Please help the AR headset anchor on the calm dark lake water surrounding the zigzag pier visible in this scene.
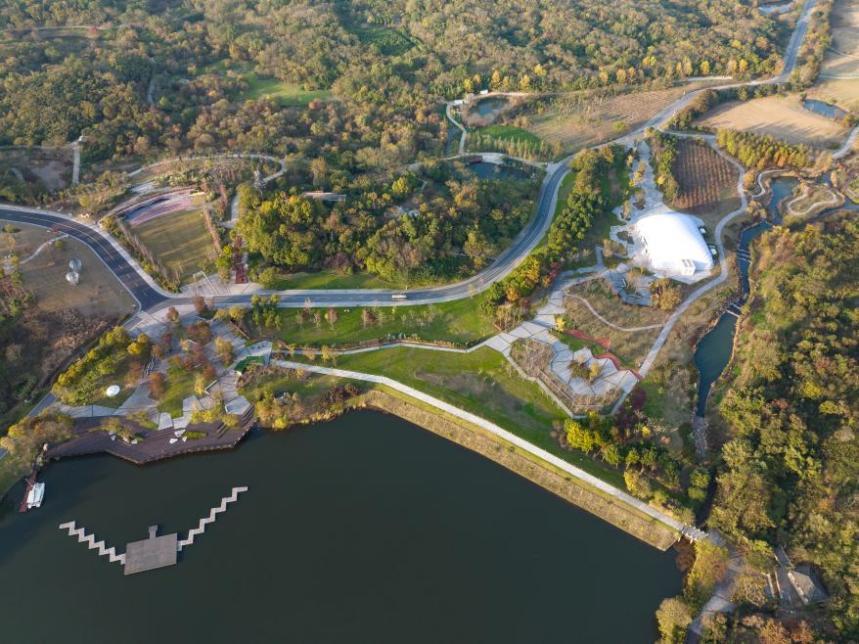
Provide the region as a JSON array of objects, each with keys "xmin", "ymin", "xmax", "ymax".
[{"xmin": 0, "ymin": 412, "xmax": 680, "ymax": 644}]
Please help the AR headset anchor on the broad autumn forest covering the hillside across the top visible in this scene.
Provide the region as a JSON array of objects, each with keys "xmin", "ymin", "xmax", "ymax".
[{"xmin": 0, "ymin": 0, "xmax": 779, "ymax": 172}]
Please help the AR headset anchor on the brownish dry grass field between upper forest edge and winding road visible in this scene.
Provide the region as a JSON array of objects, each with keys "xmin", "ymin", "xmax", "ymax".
[{"xmin": 526, "ymin": 83, "xmax": 699, "ymax": 152}]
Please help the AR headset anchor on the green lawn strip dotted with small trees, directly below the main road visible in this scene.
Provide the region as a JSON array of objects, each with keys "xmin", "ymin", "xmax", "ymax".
[{"xmin": 263, "ymin": 294, "xmax": 496, "ymax": 346}]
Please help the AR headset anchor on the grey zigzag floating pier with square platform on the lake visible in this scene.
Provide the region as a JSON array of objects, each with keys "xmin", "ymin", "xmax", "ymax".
[{"xmin": 59, "ymin": 485, "xmax": 248, "ymax": 575}]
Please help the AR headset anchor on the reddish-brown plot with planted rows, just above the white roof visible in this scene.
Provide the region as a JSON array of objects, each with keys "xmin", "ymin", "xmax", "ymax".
[{"xmin": 670, "ymin": 139, "xmax": 740, "ymax": 228}]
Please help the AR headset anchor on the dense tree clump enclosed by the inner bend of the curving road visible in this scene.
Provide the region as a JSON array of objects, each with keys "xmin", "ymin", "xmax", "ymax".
[{"xmin": 236, "ymin": 163, "xmax": 537, "ymax": 284}]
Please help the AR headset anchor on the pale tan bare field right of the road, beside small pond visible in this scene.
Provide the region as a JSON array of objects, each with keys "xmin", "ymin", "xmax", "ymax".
[{"xmin": 695, "ymin": 96, "xmax": 847, "ymax": 148}]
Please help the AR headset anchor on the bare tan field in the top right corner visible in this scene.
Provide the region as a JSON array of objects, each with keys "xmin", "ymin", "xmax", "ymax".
[{"xmin": 808, "ymin": 0, "xmax": 859, "ymax": 113}]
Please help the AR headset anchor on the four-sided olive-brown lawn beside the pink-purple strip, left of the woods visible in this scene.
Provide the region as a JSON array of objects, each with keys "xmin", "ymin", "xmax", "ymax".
[{"xmin": 133, "ymin": 210, "xmax": 215, "ymax": 281}]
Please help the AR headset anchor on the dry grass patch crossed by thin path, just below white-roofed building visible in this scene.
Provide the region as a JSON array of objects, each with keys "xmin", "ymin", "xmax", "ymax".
[{"xmin": 565, "ymin": 280, "xmax": 668, "ymax": 367}]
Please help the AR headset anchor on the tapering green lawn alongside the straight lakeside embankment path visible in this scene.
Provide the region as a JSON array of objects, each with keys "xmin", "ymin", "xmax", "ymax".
[{"xmin": 326, "ymin": 348, "xmax": 626, "ymax": 489}]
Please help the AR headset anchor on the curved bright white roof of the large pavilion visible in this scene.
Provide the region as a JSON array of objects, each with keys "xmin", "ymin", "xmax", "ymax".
[{"xmin": 635, "ymin": 210, "xmax": 713, "ymax": 276}]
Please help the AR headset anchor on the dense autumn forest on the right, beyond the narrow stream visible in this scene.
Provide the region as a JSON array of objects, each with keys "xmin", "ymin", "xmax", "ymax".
[{"xmin": 709, "ymin": 216, "xmax": 859, "ymax": 641}]
